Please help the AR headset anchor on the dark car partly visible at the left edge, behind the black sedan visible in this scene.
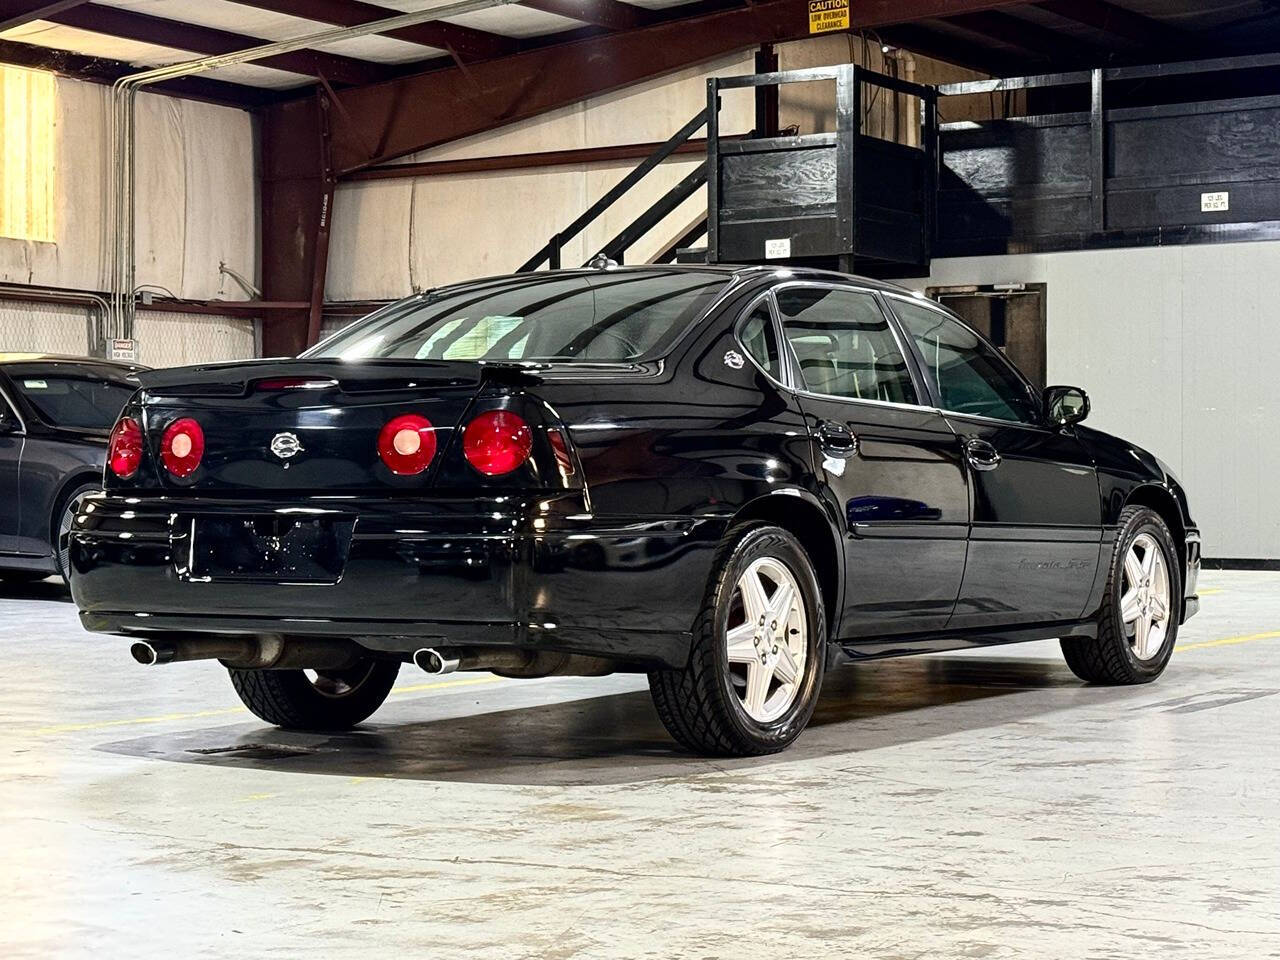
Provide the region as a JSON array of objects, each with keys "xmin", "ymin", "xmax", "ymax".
[{"xmin": 0, "ymin": 353, "xmax": 142, "ymax": 581}]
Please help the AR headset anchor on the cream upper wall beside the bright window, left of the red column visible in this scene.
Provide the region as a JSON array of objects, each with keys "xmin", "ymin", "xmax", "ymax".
[{"xmin": 0, "ymin": 78, "xmax": 257, "ymax": 300}]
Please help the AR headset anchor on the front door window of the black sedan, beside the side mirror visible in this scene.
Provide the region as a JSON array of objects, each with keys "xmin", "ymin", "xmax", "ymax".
[{"xmin": 893, "ymin": 300, "xmax": 1039, "ymax": 424}]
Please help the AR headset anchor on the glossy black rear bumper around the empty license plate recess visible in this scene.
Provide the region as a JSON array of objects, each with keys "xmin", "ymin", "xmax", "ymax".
[{"xmin": 70, "ymin": 493, "xmax": 723, "ymax": 666}]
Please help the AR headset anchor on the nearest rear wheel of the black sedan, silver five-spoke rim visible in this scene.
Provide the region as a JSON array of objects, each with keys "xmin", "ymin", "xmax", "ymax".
[{"xmin": 649, "ymin": 524, "xmax": 827, "ymax": 756}]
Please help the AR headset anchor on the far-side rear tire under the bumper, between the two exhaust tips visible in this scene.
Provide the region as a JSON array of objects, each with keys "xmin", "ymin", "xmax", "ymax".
[{"xmin": 227, "ymin": 658, "xmax": 399, "ymax": 730}]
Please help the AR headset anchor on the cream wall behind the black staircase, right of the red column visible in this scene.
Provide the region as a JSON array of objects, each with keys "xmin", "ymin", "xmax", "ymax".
[{"xmin": 326, "ymin": 54, "xmax": 754, "ymax": 301}]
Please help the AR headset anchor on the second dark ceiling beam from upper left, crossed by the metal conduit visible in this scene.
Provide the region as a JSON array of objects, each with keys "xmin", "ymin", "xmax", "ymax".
[{"xmin": 46, "ymin": 4, "xmax": 396, "ymax": 84}]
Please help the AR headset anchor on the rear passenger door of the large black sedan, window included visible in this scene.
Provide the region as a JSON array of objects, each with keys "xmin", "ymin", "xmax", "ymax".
[{"xmin": 773, "ymin": 282, "xmax": 969, "ymax": 639}]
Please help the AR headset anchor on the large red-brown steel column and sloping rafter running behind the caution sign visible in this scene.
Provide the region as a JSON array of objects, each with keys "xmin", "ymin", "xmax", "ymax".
[{"xmin": 262, "ymin": 0, "xmax": 1024, "ymax": 353}]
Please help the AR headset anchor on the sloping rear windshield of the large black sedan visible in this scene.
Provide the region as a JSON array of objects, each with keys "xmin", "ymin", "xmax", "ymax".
[{"xmin": 303, "ymin": 270, "xmax": 730, "ymax": 362}]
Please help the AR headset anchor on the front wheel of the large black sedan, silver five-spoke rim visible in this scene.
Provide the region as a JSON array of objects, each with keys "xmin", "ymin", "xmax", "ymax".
[{"xmin": 1060, "ymin": 506, "xmax": 1183, "ymax": 685}]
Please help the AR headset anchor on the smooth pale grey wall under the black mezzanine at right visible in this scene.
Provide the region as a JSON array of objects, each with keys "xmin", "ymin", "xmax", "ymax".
[{"xmin": 910, "ymin": 243, "xmax": 1280, "ymax": 559}]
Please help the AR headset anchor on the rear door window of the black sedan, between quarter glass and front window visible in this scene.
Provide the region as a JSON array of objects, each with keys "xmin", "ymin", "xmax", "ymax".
[{"xmin": 777, "ymin": 287, "xmax": 916, "ymax": 403}]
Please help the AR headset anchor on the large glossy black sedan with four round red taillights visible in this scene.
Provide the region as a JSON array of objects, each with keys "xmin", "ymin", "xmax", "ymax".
[{"xmin": 72, "ymin": 266, "xmax": 1199, "ymax": 754}]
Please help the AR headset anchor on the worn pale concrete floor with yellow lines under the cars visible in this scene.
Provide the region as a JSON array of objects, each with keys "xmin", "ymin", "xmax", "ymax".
[{"xmin": 0, "ymin": 572, "xmax": 1280, "ymax": 960}]
